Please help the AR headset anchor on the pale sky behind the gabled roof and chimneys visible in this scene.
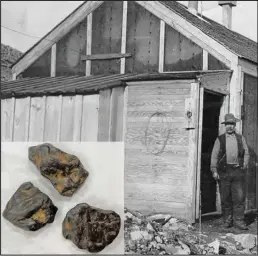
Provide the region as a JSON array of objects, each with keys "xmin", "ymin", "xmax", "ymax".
[{"xmin": 1, "ymin": 1, "xmax": 257, "ymax": 52}]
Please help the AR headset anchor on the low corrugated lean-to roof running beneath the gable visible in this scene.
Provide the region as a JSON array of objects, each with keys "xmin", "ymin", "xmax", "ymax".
[{"xmin": 1, "ymin": 70, "xmax": 230, "ymax": 99}]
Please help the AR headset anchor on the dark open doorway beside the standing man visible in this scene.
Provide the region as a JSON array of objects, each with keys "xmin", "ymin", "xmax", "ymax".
[{"xmin": 200, "ymin": 91, "xmax": 224, "ymax": 214}]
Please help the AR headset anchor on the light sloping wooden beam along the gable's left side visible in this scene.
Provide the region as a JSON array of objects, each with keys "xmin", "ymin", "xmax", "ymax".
[{"xmin": 13, "ymin": 1, "xmax": 104, "ymax": 75}]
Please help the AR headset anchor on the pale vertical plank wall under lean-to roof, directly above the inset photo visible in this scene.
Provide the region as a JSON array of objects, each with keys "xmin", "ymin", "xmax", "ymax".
[{"xmin": 1, "ymin": 94, "xmax": 99, "ymax": 142}]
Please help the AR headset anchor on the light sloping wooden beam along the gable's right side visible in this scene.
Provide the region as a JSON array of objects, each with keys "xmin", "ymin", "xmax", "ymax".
[{"xmin": 135, "ymin": 1, "xmax": 237, "ymax": 67}]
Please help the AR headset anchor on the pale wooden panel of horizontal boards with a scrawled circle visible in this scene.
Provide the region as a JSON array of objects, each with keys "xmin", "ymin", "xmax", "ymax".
[{"xmin": 125, "ymin": 81, "xmax": 197, "ymax": 222}]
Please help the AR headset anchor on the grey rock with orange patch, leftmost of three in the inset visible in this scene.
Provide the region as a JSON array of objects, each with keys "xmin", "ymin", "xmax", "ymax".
[{"xmin": 3, "ymin": 182, "xmax": 58, "ymax": 231}]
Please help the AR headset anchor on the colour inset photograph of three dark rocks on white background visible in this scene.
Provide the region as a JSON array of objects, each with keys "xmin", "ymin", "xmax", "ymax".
[{"xmin": 1, "ymin": 142, "xmax": 124, "ymax": 254}]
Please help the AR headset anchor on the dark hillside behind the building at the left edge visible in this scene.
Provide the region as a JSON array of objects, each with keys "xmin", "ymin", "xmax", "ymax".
[{"xmin": 1, "ymin": 44, "xmax": 22, "ymax": 81}]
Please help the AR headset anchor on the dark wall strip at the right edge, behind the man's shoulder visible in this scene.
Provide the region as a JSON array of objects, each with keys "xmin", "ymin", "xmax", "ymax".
[{"xmin": 242, "ymin": 74, "xmax": 258, "ymax": 210}]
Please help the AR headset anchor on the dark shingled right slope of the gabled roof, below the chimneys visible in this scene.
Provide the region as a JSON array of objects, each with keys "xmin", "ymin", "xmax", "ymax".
[{"xmin": 159, "ymin": 1, "xmax": 257, "ymax": 63}]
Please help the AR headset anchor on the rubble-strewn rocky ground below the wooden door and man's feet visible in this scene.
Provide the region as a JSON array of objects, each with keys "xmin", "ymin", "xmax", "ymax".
[{"xmin": 124, "ymin": 209, "xmax": 257, "ymax": 255}]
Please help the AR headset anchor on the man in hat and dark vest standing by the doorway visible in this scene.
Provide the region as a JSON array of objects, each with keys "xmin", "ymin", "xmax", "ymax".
[{"xmin": 211, "ymin": 114, "xmax": 249, "ymax": 230}]
